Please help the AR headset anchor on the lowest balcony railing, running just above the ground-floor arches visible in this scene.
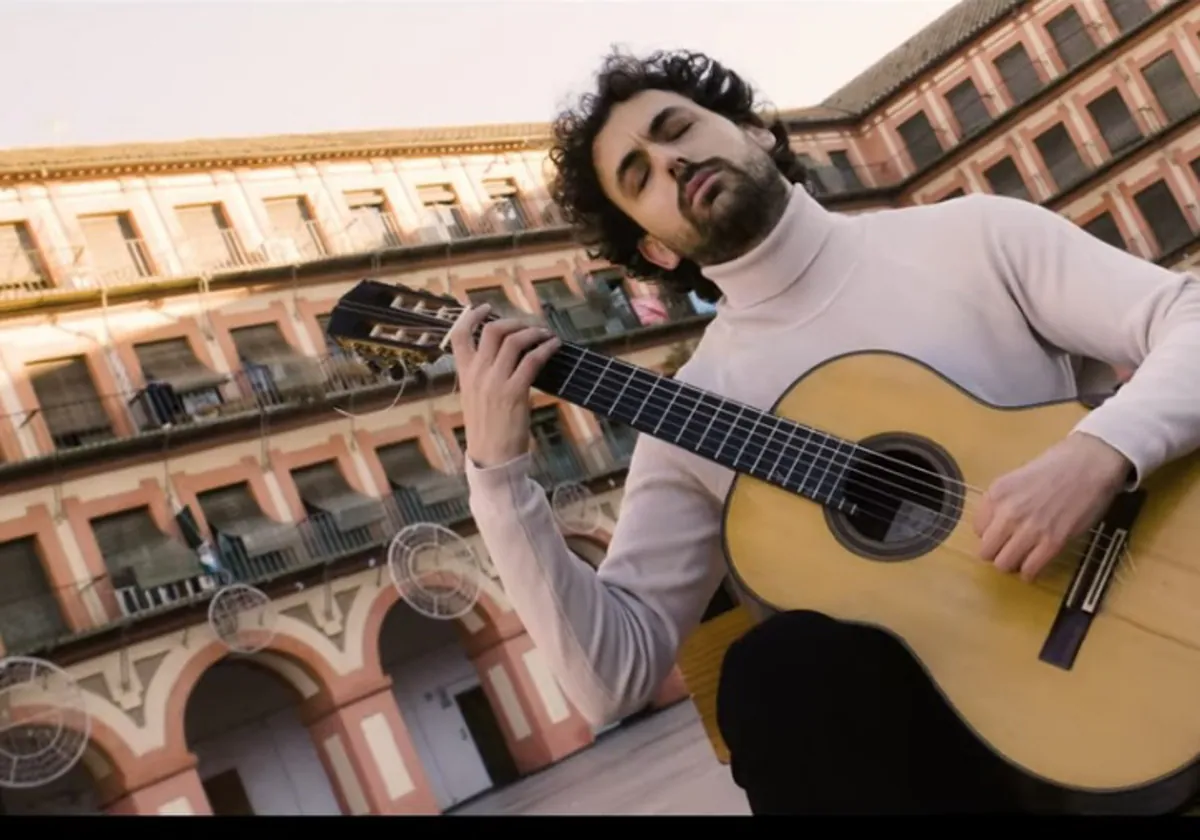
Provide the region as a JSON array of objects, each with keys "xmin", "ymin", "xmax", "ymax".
[{"xmin": 0, "ymin": 433, "xmax": 634, "ymax": 655}]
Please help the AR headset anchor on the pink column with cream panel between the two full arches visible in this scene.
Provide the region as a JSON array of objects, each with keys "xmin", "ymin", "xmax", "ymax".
[{"xmin": 305, "ymin": 680, "xmax": 440, "ymax": 816}]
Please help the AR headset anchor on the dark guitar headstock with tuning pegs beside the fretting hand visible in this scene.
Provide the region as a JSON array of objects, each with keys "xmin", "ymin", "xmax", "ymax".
[{"xmin": 328, "ymin": 280, "xmax": 463, "ymax": 368}]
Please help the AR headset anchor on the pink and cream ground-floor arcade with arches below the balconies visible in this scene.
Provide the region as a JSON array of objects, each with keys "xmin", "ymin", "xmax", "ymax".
[{"xmin": 0, "ymin": 525, "xmax": 684, "ymax": 815}]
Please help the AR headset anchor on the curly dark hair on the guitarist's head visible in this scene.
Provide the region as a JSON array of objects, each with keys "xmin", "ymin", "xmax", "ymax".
[{"xmin": 550, "ymin": 50, "xmax": 809, "ymax": 302}]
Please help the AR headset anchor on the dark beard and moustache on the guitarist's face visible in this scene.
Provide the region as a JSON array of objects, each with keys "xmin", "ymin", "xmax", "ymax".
[{"xmin": 679, "ymin": 150, "xmax": 791, "ymax": 265}]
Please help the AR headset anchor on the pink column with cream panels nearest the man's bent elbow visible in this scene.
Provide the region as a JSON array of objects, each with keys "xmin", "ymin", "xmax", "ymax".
[{"xmin": 472, "ymin": 632, "xmax": 595, "ymax": 773}]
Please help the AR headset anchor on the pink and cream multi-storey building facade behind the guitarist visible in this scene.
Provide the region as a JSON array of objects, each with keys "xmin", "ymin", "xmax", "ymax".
[{"xmin": 0, "ymin": 0, "xmax": 1200, "ymax": 815}]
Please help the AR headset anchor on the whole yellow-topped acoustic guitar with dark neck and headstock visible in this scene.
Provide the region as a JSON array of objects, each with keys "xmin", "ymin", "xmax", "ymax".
[{"xmin": 329, "ymin": 281, "xmax": 1200, "ymax": 804}]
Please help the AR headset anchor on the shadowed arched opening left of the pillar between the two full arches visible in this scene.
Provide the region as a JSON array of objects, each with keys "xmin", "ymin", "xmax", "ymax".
[{"xmin": 184, "ymin": 654, "xmax": 342, "ymax": 816}]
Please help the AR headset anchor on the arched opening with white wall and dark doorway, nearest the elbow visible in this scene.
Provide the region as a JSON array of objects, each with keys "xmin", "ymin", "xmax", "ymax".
[{"xmin": 379, "ymin": 600, "xmax": 518, "ymax": 811}]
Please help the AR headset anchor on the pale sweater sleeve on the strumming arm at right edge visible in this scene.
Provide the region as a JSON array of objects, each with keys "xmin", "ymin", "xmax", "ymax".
[{"xmin": 979, "ymin": 197, "xmax": 1200, "ymax": 486}]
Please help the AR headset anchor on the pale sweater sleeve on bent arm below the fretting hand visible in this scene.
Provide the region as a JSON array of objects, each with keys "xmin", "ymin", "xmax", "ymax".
[{"xmin": 467, "ymin": 436, "xmax": 725, "ymax": 725}]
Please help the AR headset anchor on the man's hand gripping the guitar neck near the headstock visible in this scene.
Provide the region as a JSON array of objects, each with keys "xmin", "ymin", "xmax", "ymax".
[{"xmin": 450, "ymin": 304, "xmax": 562, "ymax": 468}]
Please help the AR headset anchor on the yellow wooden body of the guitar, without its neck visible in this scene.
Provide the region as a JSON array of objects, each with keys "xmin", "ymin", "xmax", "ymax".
[{"xmin": 724, "ymin": 353, "xmax": 1200, "ymax": 802}]
